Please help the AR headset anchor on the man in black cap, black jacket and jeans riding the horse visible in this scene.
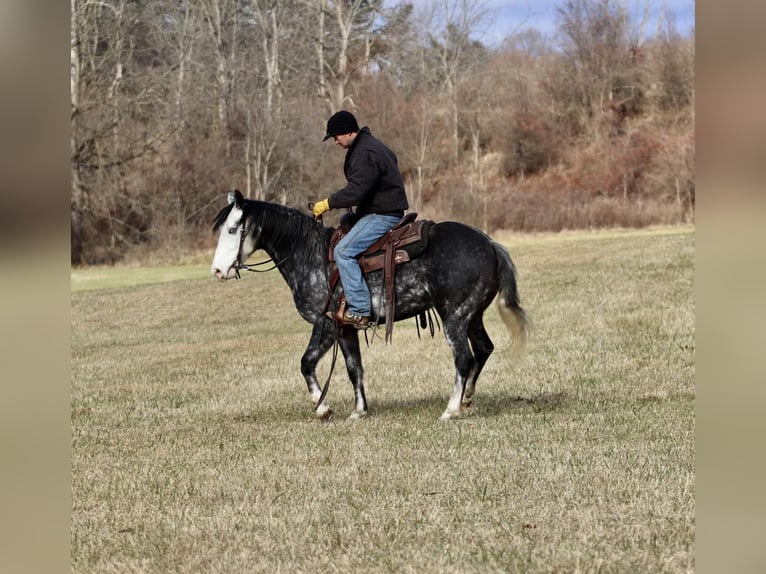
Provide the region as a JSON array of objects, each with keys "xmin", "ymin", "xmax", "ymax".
[{"xmin": 313, "ymin": 110, "xmax": 409, "ymax": 329}]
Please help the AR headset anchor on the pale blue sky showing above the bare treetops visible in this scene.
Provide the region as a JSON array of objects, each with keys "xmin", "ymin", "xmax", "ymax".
[{"xmin": 387, "ymin": 0, "xmax": 695, "ymax": 46}]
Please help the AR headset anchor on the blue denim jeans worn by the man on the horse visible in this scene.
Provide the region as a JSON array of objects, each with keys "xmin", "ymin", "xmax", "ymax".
[{"xmin": 335, "ymin": 213, "xmax": 401, "ymax": 317}]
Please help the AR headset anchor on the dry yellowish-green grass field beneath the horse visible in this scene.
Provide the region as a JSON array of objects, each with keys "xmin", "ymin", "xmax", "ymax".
[{"xmin": 71, "ymin": 227, "xmax": 695, "ymax": 573}]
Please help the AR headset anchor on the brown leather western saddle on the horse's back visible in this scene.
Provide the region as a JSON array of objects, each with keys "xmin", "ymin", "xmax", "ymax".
[{"xmin": 327, "ymin": 212, "xmax": 433, "ymax": 343}]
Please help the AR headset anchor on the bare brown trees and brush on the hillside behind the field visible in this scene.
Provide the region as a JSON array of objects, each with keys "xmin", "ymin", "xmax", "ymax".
[{"xmin": 71, "ymin": 0, "xmax": 695, "ymax": 264}]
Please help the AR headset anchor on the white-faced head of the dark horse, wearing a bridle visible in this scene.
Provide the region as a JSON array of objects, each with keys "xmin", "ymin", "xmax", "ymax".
[{"xmin": 210, "ymin": 189, "xmax": 255, "ymax": 281}]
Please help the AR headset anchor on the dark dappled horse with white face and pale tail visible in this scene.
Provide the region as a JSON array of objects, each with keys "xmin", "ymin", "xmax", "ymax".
[{"xmin": 211, "ymin": 190, "xmax": 528, "ymax": 419}]
